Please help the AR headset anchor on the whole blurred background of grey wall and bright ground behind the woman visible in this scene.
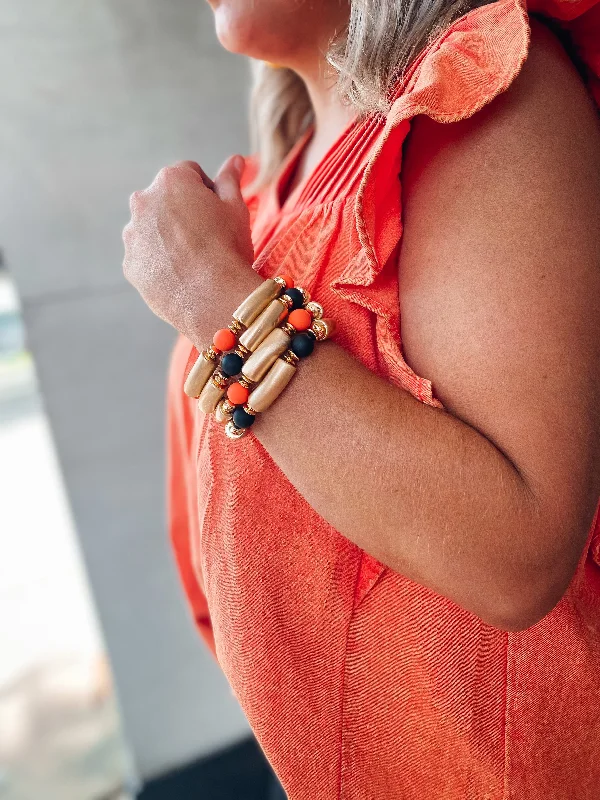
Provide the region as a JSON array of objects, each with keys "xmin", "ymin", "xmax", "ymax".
[{"xmin": 0, "ymin": 0, "xmax": 272, "ymax": 800}]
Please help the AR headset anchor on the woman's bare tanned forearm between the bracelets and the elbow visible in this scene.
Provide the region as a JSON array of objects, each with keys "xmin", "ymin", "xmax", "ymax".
[{"xmin": 192, "ymin": 273, "xmax": 540, "ymax": 626}]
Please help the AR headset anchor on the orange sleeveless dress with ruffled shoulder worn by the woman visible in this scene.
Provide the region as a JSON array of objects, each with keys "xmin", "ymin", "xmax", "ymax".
[{"xmin": 169, "ymin": 0, "xmax": 600, "ymax": 800}]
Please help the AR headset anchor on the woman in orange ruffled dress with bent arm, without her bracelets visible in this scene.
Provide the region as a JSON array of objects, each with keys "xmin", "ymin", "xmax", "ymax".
[{"xmin": 124, "ymin": 0, "xmax": 600, "ymax": 800}]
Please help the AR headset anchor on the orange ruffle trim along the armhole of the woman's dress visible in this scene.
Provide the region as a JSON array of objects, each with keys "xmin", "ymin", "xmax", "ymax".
[{"xmin": 330, "ymin": 0, "xmax": 600, "ymax": 407}]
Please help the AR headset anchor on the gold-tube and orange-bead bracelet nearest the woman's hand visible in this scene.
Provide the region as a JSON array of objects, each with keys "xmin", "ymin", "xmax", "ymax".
[{"xmin": 183, "ymin": 275, "xmax": 294, "ymax": 400}]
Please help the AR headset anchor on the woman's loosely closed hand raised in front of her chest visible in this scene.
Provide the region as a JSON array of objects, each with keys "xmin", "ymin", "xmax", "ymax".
[{"xmin": 123, "ymin": 156, "xmax": 254, "ymax": 343}]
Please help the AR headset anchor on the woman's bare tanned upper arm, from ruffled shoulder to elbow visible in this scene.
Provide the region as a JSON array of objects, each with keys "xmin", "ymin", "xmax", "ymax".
[{"xmin": 399, "ymin": 17, "xmax": 600, "ymax": 600}]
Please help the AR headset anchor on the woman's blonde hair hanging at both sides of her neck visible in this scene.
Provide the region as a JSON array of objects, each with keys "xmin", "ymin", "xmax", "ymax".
[{"xmin": 250, "ymin": 0, "xmax": 490, "ymax": 188}]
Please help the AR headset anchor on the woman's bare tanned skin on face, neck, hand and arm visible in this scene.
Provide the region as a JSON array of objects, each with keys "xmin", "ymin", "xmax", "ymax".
[{"xmin": 124, "ymin": 0, "xmax": 600, "ymax": 631}]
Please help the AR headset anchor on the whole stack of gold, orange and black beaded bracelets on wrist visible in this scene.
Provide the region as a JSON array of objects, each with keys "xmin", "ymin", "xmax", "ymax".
[{"xmin": 184, "ymin": 275, "xmax": 335, "ymax": 439}]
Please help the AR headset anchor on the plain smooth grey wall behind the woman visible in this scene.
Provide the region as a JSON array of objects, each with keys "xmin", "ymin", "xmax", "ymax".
[{"xmin": 0, "ymin": 0, "xmax": 253, "ymax": 777}]
